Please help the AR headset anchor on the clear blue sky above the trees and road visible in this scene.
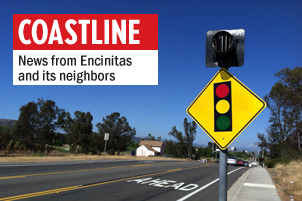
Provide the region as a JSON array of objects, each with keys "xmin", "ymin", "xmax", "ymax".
[{"xmin": 0, "ymin": 0, "xmax": 302, "ymax": 149}]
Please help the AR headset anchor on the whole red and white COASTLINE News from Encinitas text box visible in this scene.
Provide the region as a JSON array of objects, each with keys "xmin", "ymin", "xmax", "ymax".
[{"xmin": 13, "ymin": 14, "xmax": 158, "ymax": 85}]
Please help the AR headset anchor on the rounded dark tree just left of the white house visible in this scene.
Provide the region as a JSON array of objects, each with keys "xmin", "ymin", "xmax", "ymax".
[{"xmin": 96, "ymin": 112, "xmax": 136, "ymax": 155}]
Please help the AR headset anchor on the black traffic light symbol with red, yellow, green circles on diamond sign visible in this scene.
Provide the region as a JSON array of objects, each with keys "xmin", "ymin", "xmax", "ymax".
[{"xmin": 214, "ymin": 82, "xmax": 232, "ymax": 132}]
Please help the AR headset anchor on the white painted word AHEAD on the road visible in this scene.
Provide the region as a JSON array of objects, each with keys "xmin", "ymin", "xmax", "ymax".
[{"xmin": 127, "ymin": 177, "xmax": 198, "ymax": 191}]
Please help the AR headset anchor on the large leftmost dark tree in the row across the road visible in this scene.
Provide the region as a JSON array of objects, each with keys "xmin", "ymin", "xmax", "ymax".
[{"xmin": 13, "ymin": 98, "xmax": 64, "ymax": 153}]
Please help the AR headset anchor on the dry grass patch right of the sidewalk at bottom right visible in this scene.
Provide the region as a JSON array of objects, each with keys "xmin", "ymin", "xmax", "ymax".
[{"xmin": 268, "ymin": 161, "xmax": 302, "ymax": 201}]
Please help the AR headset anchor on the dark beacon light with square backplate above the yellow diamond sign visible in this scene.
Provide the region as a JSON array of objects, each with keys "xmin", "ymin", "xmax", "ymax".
[{"xmin": 206, "ymin": 29, "xmax": 245, "ymax": 68}]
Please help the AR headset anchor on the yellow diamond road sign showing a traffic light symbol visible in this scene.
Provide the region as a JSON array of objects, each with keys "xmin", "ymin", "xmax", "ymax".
[{"xmin": 187, "ymin": 68, "xmax": 266, "ymax": 150}]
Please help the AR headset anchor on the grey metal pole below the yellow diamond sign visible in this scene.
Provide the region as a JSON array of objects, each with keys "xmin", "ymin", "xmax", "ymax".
[{"xmin": 218, "ymin": 149, "xmax": 228, "ymax": 201}]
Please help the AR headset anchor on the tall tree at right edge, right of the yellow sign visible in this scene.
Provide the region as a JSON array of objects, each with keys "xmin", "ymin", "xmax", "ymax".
[{"xmin": 258, "ymin": 67, "xmax": 302, "ymax": 159}]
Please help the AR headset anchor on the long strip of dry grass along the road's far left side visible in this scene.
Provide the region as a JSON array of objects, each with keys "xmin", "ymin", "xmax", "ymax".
[{"xmin": 0, "ymin": 152, "xmax": 184, "ymax": 163}]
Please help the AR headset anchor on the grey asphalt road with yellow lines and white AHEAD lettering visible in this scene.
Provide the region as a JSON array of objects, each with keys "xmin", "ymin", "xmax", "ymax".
[{"xmin": 0, "ymin": 160, "xmax": 248, "ymax": 201}]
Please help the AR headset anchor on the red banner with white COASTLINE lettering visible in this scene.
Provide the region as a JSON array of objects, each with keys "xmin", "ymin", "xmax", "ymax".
[{"xmin": 13, "ymin": 14, "xmax": 158, "ymax": 50}]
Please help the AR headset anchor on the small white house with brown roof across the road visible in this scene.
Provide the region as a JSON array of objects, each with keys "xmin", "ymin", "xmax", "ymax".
[{"xmin": 136, "ymin": 140, "xmax": 165, "ymax": 156}]
